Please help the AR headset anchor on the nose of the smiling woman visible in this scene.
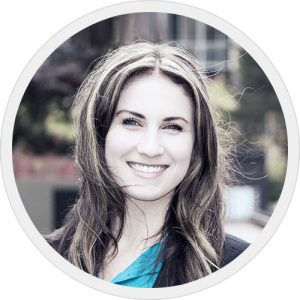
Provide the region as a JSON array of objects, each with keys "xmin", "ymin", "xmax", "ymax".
[{"xmin": 137, "ymin": 132, "xmax": 165, "ymax": 157}]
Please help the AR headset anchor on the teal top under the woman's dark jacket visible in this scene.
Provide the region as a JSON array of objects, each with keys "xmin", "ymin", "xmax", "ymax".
[{"xmin": 111, "ymin": 243, "xmax": 162, "ymax": 288}]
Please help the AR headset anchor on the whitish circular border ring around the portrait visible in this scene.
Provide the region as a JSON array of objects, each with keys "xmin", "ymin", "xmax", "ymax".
[{"xmin": 1, "ymin": 1, "xmax": 299, "ymax": 299}]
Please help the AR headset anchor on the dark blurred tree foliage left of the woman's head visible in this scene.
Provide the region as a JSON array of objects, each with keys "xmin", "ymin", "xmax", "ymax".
[{"xmin": 13, "ymin": 19, "xmax": 112, "ymax": 154}]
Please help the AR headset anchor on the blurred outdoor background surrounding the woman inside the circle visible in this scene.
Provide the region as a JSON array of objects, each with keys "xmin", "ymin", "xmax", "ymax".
[{"xmin": 13, "ymin": 13, "xmax": 287, "ymax": 242}]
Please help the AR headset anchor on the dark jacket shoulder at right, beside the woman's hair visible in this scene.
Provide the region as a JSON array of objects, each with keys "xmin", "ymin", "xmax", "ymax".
[{"xmin": 221, "ymin": 234, "xmax": 250, "ymax": 267}]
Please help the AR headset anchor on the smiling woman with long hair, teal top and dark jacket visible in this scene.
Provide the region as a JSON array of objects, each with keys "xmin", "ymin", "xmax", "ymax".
[{"xmin": 46, "ymin": 42, "xmax": 248, "ymax": 287}]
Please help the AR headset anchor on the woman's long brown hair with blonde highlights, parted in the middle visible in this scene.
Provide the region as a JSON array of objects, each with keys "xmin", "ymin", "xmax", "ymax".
[{"xmin": 46, "ymin": 41, "xmax": 231, "ymax": 286}]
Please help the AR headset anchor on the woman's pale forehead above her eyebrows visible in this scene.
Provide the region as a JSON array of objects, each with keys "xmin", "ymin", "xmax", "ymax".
[{"xmin": 117, "ymin": 74, "xmax": 192, "ymax": 120}]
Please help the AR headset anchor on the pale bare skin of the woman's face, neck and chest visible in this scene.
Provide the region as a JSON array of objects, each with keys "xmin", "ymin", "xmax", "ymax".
[{"xmin": 102, "ymin": 74, "xmax": 194, "ymax": 280}]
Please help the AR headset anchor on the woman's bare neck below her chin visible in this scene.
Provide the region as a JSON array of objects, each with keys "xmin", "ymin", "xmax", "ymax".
[{"xmin": 122, "ymin": 195, "xmax": 171, "ymax": 248}]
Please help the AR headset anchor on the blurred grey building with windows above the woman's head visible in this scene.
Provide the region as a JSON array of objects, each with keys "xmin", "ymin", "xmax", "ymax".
[{"xmin": 69, "ymin": 13, "xmax": 240, "ymax": 84}]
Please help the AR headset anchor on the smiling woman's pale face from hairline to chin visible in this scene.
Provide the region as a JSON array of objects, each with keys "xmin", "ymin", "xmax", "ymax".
[{"xmin": 105, "ymin": 75, "xmax": 194, "ymax": 201}]
